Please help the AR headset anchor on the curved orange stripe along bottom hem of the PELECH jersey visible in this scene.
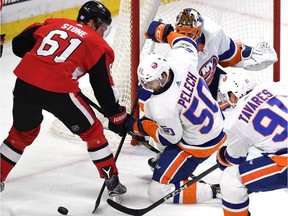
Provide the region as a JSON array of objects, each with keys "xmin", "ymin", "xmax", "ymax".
[{"xmin": 177, "ymin": 134, "xmax": 227, "ymax": 158}]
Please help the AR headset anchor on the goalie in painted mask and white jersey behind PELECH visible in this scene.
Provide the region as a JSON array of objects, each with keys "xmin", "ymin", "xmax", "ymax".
[{"xmin": 140, "ymin": 8, "xmax": 277, "ymax": 109}]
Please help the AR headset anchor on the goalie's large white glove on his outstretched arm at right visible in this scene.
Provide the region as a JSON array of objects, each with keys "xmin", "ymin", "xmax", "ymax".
[{"xmin": 234, "ymin": 42, "xmax": 278, "ymax": 71}]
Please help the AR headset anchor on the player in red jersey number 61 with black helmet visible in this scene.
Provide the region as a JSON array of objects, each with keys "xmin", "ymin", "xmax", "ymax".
[{"xmin": 1, "ymin": 1, "xmax": 127, "ymax": 201}]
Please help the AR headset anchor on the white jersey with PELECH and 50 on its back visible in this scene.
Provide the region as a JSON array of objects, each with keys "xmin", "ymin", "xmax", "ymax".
[{"xmin": 144, "ymin": 38, "xmax": 226, "ymax": 157}]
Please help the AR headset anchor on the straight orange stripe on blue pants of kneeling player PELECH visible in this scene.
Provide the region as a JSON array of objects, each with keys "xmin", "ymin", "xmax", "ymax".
[{"xmin": 160, "ymin": 151, "xmax": 190, "ymax": 184}]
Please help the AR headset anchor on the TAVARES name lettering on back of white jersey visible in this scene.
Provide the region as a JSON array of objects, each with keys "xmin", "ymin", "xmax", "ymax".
[{"xmin": 238, "ymin": 89, "xmax": 273, "ymax": 123}]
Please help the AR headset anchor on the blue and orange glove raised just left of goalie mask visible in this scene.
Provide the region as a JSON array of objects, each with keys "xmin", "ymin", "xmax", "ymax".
[{"xmin": 145, "ymin": 21, "xmax": 174, "ymax": 43}]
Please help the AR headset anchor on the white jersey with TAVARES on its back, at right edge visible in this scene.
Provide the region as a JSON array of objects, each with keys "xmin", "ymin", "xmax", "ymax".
[{"xmin": 224, "ymin": 82, "xmax": 288, "ymax": 164}]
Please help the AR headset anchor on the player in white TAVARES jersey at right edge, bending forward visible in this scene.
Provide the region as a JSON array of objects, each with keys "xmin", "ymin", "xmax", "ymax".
[{"xmin": 217, "ymin": 73, "xmax": 288, "ymax": 216}]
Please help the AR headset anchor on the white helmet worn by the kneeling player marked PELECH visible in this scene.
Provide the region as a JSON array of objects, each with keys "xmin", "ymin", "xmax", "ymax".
[{"xmin": 137, "ymin": 53, "xmax": 170, "ymax": 87}]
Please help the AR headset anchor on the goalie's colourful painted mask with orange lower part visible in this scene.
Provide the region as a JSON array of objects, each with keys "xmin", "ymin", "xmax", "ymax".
[{"xmin": 175, "ymin": 8, "xmax": 204, "ymax": 41}]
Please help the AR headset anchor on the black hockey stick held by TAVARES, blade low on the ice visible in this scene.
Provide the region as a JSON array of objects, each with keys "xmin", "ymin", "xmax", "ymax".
[{"xmin": 107, "ymin": 164, "xmax": 218, "ymax": 215}]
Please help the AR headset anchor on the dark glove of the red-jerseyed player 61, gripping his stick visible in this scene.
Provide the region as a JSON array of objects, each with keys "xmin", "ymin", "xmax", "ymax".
[{"xmin": 108, "ymin": 106, "xmax": 129, "ymax": 137}]
